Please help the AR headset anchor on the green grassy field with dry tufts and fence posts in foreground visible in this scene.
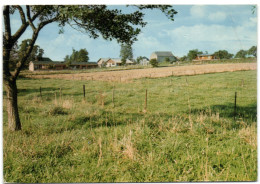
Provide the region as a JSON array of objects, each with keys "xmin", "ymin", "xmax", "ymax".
[{"xmin": 3, "ymin": 71, "xmax": 257, "ymax": 183}]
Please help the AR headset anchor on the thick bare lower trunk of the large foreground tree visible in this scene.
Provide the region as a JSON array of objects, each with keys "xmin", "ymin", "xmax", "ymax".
[{"xmin": 4, "ymin": 80, "xmax": 21, "ymax": 131}]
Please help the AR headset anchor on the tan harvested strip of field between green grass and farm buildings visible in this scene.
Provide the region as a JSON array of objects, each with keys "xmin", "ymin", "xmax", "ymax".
[{"xmin": 26, "ymin": 63, "xmax": 257, "ymax": 82}]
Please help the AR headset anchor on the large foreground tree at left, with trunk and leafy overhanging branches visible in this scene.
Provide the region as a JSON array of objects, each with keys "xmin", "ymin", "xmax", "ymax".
[{"xmin": 3, "ymin": 5, "xmax": 177, "ymax": 131}]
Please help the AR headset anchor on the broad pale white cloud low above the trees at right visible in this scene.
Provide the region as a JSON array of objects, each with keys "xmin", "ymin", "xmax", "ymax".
[{"xmin": 168, "ymin": 24, "xmax": 257, "ymax": 54}]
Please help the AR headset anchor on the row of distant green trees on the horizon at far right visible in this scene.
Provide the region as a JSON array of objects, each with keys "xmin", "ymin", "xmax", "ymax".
[{"xmin": 180, "ymin": 46, "xmax": 257, "ymax": 61}]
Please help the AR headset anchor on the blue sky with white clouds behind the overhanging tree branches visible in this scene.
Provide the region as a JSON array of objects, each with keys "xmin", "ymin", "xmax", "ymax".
[{"xmin": 8, "ymin": 5, "xmax": 257, "ymax": 61}]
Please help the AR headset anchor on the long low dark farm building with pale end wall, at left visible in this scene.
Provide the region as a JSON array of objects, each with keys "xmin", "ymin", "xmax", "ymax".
[{"xmin": 29, "ymin": 61, "xmax": 98, "ymax": 71}]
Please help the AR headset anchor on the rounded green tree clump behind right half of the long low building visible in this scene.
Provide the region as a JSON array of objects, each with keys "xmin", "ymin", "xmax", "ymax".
[{"xmin": 64, "ymin": 48, "xmax": 89, "ymax": 63}]
